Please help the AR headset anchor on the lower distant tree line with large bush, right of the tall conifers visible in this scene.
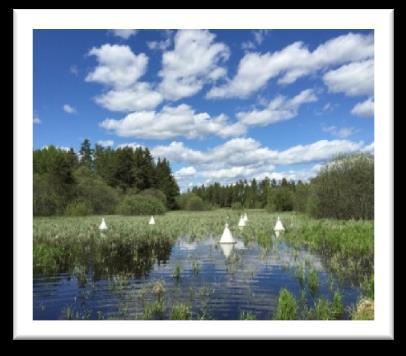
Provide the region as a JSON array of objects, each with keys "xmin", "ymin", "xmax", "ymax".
[{"xmin": 181, "ymin": 153, "xmax": 374, "ymax": 219}]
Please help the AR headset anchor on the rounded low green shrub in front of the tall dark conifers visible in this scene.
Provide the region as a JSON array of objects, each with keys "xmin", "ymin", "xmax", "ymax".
[{"xmin": 117, "ymin": 195, "xmax": 166, "ymax": 215}]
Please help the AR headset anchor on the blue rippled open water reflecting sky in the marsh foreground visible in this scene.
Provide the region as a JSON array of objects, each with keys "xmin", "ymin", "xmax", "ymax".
[{"xmin": 33, "ymin": 238, "xmax": 359, "ymax": 320}]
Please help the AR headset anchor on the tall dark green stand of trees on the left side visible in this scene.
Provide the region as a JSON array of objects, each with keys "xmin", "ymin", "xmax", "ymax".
[{"xmin": 33, "ymin": 139, "xmax": 179, "ymax": 215}]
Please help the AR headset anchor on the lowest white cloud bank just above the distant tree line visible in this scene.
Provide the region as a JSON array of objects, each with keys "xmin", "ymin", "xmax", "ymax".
[{"xmin": 155, "ymin": 138, "xmax": 371, "ymax": 186}]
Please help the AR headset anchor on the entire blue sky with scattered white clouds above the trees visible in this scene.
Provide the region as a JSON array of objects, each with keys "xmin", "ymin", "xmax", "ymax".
[{"xmin": 33, "ymin": 30, "xmax": 374, "ymax": 189}]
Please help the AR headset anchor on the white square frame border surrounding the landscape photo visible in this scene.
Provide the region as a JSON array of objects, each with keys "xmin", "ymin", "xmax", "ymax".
[{"xmin": 13, "ymin": 10, "xmax": 394, "ymax": 339}]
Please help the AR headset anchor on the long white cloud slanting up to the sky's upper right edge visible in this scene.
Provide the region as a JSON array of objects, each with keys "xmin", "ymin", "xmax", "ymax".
[{"xmin": 207, "ymin": 33, "xmax": 374, "ymax": 98}]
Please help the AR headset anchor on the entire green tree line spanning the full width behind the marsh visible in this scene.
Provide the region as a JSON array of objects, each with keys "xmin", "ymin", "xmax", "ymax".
[{"xmin": 33, "ymin": 139, "xmax": 374, "ymax": 219}]
